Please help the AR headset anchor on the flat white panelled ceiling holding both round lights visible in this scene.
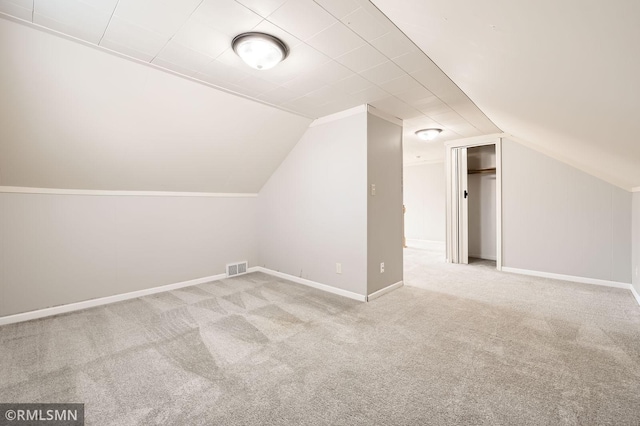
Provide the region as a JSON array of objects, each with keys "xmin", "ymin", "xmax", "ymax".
[{"xmin": 0, "ymin": 0, "xmax": 500, "ymax": 166}]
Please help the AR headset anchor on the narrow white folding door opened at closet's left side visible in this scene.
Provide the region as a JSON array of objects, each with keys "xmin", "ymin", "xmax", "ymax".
[{"xmin": 451, "ymin": 148, "xmax": 469, "ymax": 263}]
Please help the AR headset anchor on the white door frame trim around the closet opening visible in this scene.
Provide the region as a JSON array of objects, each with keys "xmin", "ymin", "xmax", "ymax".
[{"xmin": 444, "ymin": 134, "xmax": 502, "ymax": 271}]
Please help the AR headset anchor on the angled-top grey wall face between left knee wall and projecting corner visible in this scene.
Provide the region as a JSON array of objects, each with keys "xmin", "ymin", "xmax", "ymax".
[{"xmin": 258, "ymin": 108, "xmax": 367, "ymax": 296}]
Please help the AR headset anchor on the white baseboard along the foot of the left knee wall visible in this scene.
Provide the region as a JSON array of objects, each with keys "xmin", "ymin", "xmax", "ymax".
[{"xmin": 0, "ymin": 274, "xmax": 227, "ymax": 325}]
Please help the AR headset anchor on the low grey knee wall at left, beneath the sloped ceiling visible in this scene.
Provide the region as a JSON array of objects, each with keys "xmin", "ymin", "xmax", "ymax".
[{"xmin": 0, "ymin": 193, "xmax": 257, "ymax": 316}]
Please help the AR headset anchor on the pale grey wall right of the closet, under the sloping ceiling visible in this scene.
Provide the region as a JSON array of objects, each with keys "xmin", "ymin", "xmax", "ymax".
[{"xmin": 502, "ymin": 139, "xmax": 631, "ymax": 283}]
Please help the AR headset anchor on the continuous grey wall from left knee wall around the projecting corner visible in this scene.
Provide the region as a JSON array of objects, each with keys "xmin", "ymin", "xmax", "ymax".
[{"xmin": 0, "ymin": 107, "xmax": 402, "ymax": 316}]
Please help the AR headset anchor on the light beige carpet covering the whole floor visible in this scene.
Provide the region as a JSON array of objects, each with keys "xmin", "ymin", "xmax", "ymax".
[{"xmin": 0, "ymin": 249, "xmax": 640, "ymax": 425}]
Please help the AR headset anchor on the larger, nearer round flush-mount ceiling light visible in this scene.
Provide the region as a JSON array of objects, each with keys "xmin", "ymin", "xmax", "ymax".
[{"xmin": 231, "ymin": 32, "xmax": 289, "ymax": 70}]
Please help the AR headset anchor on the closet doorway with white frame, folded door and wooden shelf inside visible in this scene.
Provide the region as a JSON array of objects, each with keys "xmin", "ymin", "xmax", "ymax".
[{"xmin": 445, "ymin": 138, "xmax": 502, "ymax": 270}]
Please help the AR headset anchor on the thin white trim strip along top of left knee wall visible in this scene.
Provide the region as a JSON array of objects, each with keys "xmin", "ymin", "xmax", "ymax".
[{"xmin": 0, "ymin": 186, "xmax": 258, "ymax": 198}]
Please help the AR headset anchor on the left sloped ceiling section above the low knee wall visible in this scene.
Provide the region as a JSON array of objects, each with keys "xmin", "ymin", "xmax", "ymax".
[{"xmin": 0, "ymin": 19, "xmax": 311, "ymax": 193}]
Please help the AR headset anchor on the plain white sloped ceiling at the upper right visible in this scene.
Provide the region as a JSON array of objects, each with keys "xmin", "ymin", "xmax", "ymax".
[{"xmin": 372, "ymin": 0, "xmax": 640, "ymax": 189}]
